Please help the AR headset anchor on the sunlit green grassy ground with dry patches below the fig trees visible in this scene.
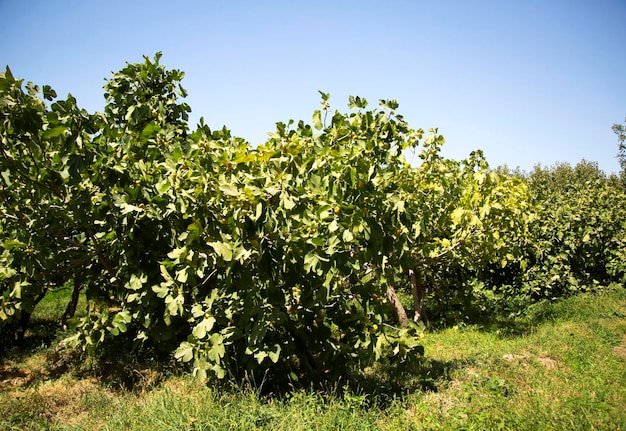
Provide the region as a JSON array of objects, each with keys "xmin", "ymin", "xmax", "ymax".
[{"xmin": 0, "ymin": 289, "xmax": 626, "ymax": 431}]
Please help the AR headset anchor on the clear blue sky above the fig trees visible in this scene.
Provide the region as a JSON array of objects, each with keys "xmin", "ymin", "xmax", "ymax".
[{"xmin": 0, "ymin": 0, "xmax": 626, "ymax": 172}]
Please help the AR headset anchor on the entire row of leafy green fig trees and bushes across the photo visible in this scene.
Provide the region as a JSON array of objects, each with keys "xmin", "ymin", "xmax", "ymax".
[{"xmin": 0, "ymin": 54, "xmax": 626, "ymax": 381}]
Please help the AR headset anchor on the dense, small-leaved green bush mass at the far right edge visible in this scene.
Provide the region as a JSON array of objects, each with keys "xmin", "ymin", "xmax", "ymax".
[{"xmin": 485, "ymin": 161, "xmax": 626, "ymax": 309}]
